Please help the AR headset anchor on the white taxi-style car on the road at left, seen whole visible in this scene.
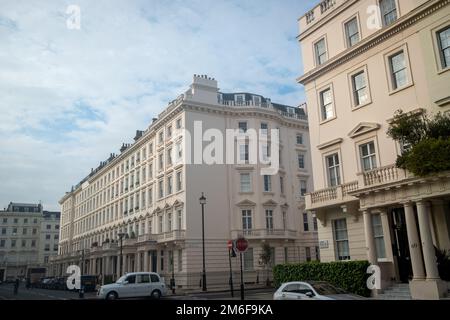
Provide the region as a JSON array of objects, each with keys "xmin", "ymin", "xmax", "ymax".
[{"xmin": 98, "ymin": 272, "xmax": 167, "ymax": 300}]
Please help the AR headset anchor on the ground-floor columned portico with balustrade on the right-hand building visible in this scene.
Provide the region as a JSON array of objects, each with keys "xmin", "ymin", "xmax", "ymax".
[{"xmin": 307, "ymin": 169, "xmax": 450, "ymax": 299}]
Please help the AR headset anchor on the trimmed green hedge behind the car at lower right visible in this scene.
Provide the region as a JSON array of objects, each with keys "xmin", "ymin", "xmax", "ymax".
[{"xmin": 273, "ymin": 261, "xmax": 370, "ymax": 297}]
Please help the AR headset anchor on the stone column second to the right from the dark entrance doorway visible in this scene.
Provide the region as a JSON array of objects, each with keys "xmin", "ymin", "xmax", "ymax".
[{"xmin": 416, "ymin": 201, "xmax": 440, "ymax": 280}]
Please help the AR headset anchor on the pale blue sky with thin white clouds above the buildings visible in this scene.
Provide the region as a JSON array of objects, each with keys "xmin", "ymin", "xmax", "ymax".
[{"xmin": 0, "ymin": 0, "xmax": 317, "ymax": 210}]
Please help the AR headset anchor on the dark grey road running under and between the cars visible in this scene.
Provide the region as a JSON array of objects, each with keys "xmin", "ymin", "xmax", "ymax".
[{"xmin": 0, "ymin": 284, "xmax": 274, "ymax": 300}]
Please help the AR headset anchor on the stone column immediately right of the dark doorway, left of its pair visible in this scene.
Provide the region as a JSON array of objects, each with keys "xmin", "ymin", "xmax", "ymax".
[{"xmin": 403, "ymin": 202, "xmax": 425, "ymax": 280}]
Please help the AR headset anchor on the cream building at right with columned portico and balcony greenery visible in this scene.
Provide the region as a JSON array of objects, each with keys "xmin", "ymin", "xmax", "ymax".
[{"xmin": 298, "ymin": 0, "xmax": 450, "ymax": 299}]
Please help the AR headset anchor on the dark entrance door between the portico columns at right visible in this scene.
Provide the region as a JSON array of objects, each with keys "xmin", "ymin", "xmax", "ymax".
[{"xmin": 391, "ymin": 208, "xmax": 412, "ymax": 283}]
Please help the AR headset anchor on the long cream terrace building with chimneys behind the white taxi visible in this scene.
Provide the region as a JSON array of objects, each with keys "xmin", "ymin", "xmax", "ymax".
[{"xmin": 53, "ymin": 76, "xmax": 318, "ymax": 289}]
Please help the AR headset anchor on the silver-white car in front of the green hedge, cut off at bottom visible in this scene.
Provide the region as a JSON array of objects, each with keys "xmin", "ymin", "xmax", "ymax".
[{"xmin": 273, "ymin": 281, "xmax": 365, "ymax": 300}]
